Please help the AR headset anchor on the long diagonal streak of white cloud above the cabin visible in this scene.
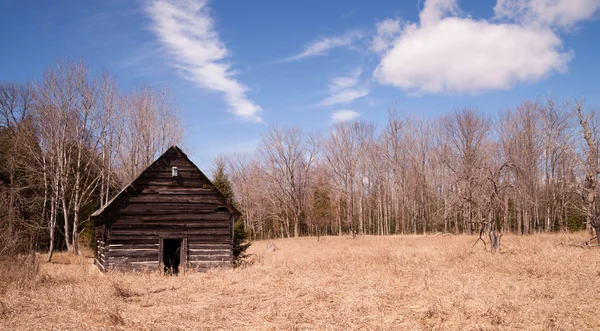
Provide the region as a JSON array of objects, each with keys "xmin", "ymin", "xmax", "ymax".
[{"xmin": 146, "ymin": 0, "xmax": 262, "ymax": 122}]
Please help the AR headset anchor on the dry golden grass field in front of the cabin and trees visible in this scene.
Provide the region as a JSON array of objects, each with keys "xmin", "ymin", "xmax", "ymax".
[{"xmin": 0, "ymin": 234, "xmax": 600, "ymax": 330}]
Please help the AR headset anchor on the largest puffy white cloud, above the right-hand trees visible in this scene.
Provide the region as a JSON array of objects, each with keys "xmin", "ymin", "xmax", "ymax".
[{"xmin": 374, "ymin": 0, "xmax": 573, "ymax": 93}]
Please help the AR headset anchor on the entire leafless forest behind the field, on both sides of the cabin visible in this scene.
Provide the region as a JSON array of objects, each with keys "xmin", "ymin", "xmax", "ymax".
[{"xmin": 0, "ymin": 58, "xmax": 600, "ymax": 260}]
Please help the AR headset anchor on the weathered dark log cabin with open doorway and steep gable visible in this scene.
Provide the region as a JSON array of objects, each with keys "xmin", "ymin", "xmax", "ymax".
[{"xmin": 91, "ymin": 146, "xmax": 240, "ymax": 273}]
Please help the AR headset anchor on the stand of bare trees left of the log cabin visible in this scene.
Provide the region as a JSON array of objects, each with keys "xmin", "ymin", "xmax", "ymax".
[{"xmin": 0, "ymin": 58, "xmax": 183, "ymax": 260}]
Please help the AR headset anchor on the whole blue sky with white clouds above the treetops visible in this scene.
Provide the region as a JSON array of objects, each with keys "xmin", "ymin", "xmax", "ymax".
[{"xmin": 0, "ymin": 0, "xmax": 600, "ymax": 168}]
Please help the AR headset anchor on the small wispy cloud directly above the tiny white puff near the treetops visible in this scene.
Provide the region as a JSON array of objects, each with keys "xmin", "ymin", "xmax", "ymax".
[{"xmin": 319, "ymin": 68, "xmax": 369, "ymax": 106}]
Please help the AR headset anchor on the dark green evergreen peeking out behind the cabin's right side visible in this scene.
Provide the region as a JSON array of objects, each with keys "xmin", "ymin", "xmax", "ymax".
[{"xmin": 213, "ymin": 158, "xmax": 252, "ymax": 267}]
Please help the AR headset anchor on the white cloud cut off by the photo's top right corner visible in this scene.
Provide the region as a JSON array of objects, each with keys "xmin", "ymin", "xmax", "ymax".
[{"xmin": 494, "ymin": 0, "xmax": 600, "ymax": 28}]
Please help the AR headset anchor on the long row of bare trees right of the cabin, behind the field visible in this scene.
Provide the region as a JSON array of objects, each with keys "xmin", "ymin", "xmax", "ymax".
[{"xmin": 223, "ymin": 98, "xmax": 600, "ymax": 238}]
